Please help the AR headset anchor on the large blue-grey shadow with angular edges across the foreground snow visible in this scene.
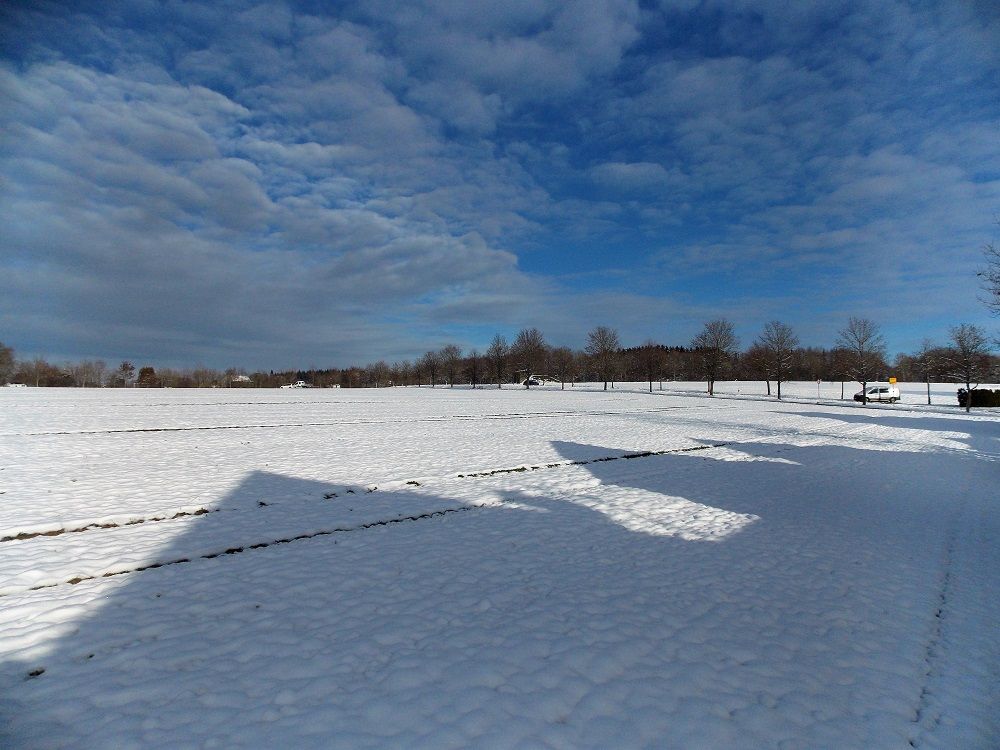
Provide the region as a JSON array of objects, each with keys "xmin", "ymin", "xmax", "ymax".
[{"xmin": 0, "ymin": 443, "xmax": 996, "ymax": 748}]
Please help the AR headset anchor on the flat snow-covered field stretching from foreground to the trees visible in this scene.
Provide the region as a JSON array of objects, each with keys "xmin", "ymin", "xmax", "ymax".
[{"xmin": 0, "ymin": 383, "xmax": 1000, "ymax": 748}]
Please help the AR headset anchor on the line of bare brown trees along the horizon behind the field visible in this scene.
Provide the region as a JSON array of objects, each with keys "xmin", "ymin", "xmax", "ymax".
[{"xmin": 0, "ymin": 318, "xmax": 1000, "ymax": 412}]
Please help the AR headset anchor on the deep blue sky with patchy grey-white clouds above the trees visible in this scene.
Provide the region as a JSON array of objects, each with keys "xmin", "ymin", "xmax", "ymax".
[{"xmin": 0, "ymin": 0, "xmax": 1000, "ymax": 368}]
